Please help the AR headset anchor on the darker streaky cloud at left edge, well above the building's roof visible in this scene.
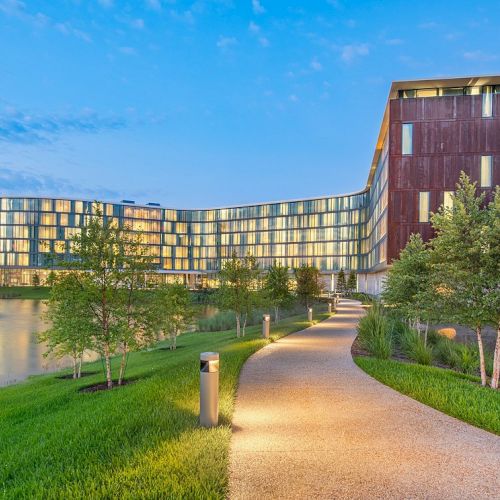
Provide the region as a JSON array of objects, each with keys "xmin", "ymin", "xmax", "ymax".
[{"xmin": 0, "ymin": 110, "xmax": 127, "ymax": 144}]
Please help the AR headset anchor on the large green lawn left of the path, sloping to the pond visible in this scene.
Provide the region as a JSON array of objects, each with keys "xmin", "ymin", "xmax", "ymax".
[{"xmin": 0, "ymin": 314, "xmax": 328, "ymax": 499}]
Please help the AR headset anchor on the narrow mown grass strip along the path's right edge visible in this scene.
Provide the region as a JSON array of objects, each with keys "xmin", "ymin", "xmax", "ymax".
[{"xmin": 355, "ymin": 357, "xmax": 500, "ymax": 435}]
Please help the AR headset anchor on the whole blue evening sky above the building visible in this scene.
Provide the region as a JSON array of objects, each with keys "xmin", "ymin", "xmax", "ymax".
[{"xmin": 0, "ymin": 0, "xmax": 500, "ymax": 207}]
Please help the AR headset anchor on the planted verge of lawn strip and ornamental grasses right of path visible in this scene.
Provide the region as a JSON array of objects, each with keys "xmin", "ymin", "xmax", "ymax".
[{"xmin": 352, "ymin": 303, "xmax": 500, "ymax": 434}]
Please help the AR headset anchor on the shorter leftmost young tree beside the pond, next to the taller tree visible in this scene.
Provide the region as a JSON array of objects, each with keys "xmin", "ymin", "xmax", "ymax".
[{"xmin": 38, "ymin": 274, "xmax": 95, "ymax": 379}]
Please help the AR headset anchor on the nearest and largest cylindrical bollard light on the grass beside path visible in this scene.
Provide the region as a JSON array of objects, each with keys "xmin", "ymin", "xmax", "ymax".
[{"xmin": 200, "ymin": 352, "xmax": 219, "ymax": 427}]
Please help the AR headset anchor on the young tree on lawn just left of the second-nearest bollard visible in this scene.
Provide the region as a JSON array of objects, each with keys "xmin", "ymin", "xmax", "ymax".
[{"xmin": 217, "ymin": 252, "xmax": 260, "ymax": 337}]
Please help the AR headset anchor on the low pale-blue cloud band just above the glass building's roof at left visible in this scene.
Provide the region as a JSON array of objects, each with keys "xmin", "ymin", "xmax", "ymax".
[{"xmin": 0, "ymin": 166, "xmax": 121, "ymax": 200}]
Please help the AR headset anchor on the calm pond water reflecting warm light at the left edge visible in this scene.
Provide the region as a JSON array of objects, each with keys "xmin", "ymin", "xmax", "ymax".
[{"xmin": 0, "ymin": 299, "xmax": 217, "ymax": 387}]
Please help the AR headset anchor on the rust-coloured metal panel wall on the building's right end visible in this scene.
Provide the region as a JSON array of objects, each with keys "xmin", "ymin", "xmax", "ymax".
[{"xmin": 387, "ymin": 94, "xmax": 500, "ymax": 262}]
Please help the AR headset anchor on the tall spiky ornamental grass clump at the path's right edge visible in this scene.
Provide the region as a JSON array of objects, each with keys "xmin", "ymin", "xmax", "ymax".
[{"xmin": 358, "ymin": 303, "xmax": 393, "ymax": 359}]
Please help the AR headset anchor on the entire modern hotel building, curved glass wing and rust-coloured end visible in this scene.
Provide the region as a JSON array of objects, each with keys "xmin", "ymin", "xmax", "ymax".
[{"xmin": 0, "ymin": 76, "xmax": 500, "ymax": 293}]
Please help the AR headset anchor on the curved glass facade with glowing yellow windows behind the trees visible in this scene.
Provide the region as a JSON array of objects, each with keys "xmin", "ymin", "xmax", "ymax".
[{"xmin": 0, "ymin": 141, "xmax": 387, "ymax": 284}]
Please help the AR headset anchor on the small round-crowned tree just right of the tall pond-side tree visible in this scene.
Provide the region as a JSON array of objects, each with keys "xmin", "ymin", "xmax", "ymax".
[{"xmin": 154, "ymin": 282, "xmax": 194, "ymax": 350}]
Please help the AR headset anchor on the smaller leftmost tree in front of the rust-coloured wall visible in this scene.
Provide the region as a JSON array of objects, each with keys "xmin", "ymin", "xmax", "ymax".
[{"xmin": 382, "ymin": 234, "xmax": 436, "ymax": 344}]
